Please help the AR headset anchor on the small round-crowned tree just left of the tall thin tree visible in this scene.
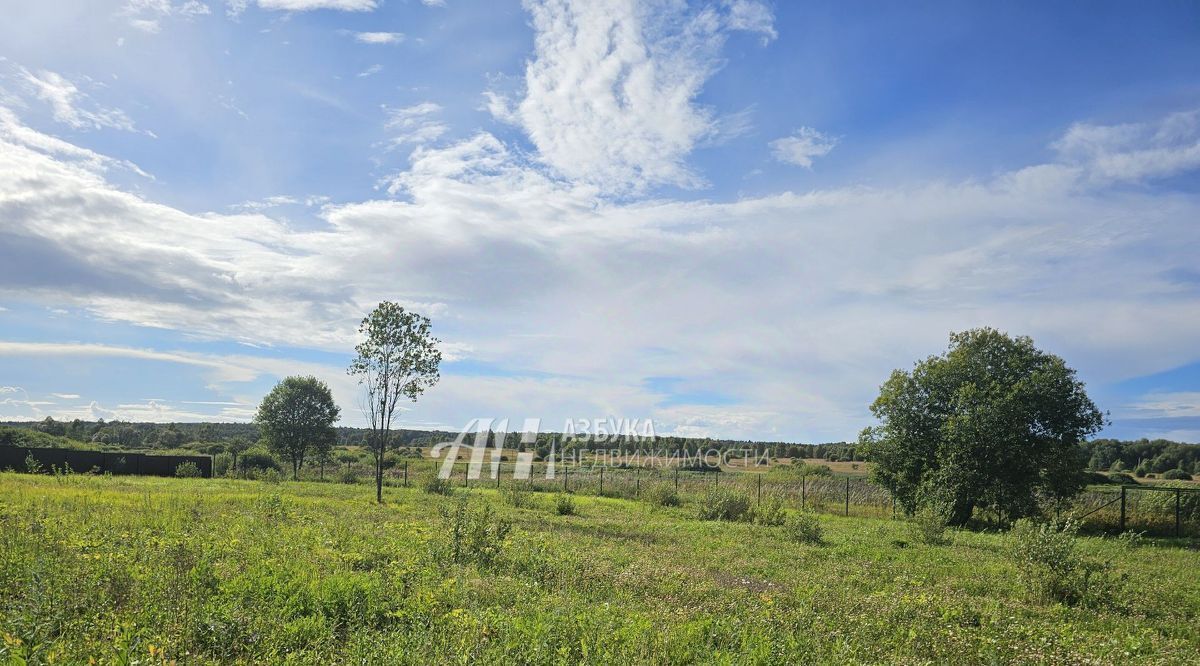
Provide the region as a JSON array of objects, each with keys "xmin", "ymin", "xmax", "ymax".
[{"xmin": 254, "ymin": 377, "xmax": 341, "ymax": 479}]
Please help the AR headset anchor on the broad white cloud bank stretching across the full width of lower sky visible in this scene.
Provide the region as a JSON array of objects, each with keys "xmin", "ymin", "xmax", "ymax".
[{"xmin": 0, "ymin": 104, "xmax": 1200, "ymax": 439}]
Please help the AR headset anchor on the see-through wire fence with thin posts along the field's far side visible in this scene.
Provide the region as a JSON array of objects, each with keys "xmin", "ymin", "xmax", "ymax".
[{"xmin": 389, "ymin": 460, "xmax": 1200, "ymax": 536}]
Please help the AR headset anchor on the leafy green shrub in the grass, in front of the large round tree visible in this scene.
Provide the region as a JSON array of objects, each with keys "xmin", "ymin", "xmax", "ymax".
[{"xmin": 1009, "ymin": 518, "xmax": 1123, "ymax": 607}]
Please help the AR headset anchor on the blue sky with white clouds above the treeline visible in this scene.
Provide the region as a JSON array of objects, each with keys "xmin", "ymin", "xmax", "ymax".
[{"xmin": 0, "ymin": 0, "xmax": 1200, "ymax": 442}]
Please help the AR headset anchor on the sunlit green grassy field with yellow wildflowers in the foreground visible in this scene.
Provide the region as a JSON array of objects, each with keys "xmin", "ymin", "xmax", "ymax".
[{"xmin": 0, "ymin": 473, "xmax": 1200, "ymax": 665}]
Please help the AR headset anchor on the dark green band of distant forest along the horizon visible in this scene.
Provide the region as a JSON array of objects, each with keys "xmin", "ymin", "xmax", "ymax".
[{"xmin": 0, "ymin": 418, "xmax": 1200, "ymax": 476}]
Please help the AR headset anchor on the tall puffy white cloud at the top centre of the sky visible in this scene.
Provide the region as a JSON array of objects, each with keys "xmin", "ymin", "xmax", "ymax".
[{"xmin": 487, "ymin": 0, "xmax": 761, "ymax": 193}]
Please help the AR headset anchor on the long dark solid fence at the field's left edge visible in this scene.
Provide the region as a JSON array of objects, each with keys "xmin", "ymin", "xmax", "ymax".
[{"xmin": 0, "ymin": 446, "xmax": 212, "ymax": 479}]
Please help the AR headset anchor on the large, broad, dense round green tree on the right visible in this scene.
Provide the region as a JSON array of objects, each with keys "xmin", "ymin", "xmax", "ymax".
[{"xmin": 862, "ymin": 329, "xmax": 1104, "ymax": 524}]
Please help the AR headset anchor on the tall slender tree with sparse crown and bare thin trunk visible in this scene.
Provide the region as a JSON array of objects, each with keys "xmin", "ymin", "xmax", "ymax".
[{"xmin": 347, "ymin": 301, "xmax": 442, "ymax": 503}]
